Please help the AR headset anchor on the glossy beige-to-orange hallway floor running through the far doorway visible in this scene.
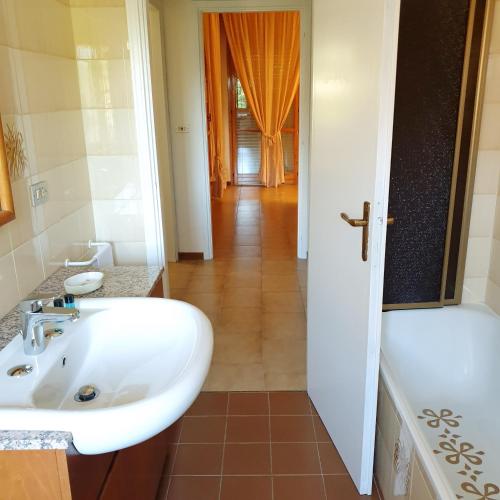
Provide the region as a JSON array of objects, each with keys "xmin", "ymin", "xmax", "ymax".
[{"xmin": 169, "ymin": 185, "xmax": 306, "ymax": 391}]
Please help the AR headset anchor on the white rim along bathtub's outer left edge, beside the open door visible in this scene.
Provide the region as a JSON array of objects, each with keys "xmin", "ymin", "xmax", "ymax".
[{"xmin": 380, "ymin": 352, "xmax": 456, "ymax": 500}]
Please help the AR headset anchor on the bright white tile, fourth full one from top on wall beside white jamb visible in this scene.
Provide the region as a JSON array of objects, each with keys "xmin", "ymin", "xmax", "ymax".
[{"xmin": 88, "ymin": 156, "xmax": 142, "ymax": 200}]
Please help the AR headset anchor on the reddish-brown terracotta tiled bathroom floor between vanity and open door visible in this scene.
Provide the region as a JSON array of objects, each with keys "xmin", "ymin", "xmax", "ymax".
[{"xmin": 165, "ymin": 391, "xmax": 379, "ymax": 500}]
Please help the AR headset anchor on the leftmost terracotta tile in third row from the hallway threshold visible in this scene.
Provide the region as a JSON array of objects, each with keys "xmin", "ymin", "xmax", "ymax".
[{"xmin": 173, "ymin": 444, "xmax": 223, "ymax": 476}]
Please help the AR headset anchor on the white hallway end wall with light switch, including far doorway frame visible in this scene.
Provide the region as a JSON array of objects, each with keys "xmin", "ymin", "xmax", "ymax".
[{"xmin": 163, "ymin": 0, "xmax": 310, "ymax": 258}]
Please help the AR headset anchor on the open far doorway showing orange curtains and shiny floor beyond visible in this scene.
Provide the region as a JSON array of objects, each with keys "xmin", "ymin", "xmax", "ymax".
[{"xmin": 203, "ymin": 11, "xmax": 300, "ymax": 266}]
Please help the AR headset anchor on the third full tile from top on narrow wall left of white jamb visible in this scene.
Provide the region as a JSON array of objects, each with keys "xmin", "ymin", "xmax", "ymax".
[{"xmin": 82, "ymin": 109, "xmax": 137, "ymax": 156}]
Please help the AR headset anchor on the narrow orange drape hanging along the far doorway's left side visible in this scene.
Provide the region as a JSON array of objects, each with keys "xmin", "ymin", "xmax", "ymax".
[{"xmin": 203, "ymin": 13, "xmax": 226, "ymax": 198}]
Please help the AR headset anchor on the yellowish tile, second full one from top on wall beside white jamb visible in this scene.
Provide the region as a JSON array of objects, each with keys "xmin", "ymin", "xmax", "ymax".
[{"xmin": 78, "ymin": 59, "xmax": 133, "ymax": 108}]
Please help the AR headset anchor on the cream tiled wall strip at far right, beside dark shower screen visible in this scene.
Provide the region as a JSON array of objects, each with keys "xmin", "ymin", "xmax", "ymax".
[{"xmin": 462, "ymin": 0, "xmax": 500, "ymax": 312}]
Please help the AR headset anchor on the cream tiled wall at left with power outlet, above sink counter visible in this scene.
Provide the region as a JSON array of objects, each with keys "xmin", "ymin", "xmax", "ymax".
[{"xmin": 0, "ymin": 0, "xmax": 95, "ymax": 317}]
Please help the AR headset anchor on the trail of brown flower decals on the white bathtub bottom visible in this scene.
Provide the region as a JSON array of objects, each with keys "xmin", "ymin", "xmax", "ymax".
[{"xmin": 418, "ymin": 408, "xmax": 500, "ymax": 500}]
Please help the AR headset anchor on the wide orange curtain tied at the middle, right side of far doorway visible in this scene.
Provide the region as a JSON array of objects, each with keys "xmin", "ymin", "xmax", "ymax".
[{"xmin": 222, "ymin": 12, "xmax": 300, "ymax": 187}]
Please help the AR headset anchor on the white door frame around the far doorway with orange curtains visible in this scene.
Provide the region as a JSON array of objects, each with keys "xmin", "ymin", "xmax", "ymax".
[{"xmin": 196, "ymin": 0, "xmax": 312, "ymax": 259}]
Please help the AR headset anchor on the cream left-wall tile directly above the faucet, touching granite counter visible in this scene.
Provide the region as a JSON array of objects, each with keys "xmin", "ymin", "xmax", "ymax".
[{"xmin": 13, "ymin": 238, "xmax": 44, "ymax": 297}]
